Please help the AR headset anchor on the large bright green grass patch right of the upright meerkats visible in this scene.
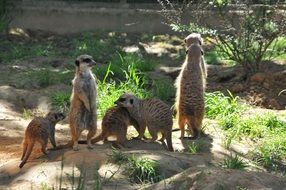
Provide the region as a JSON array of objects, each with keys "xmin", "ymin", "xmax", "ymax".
[{"xmin": 204, "ymin": 92, "xmax": 286, "ymax": 171}]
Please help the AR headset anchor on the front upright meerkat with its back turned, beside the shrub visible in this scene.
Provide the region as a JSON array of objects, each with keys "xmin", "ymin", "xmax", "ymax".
[{"xmin": 176, "ymin": 43, "xmax": 205, "ymax": 138}]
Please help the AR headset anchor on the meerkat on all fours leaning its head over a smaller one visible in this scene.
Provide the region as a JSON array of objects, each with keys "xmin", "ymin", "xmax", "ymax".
[{"xmin": 115, "ymin": 93, "xmax": 174, "ymax": 151}]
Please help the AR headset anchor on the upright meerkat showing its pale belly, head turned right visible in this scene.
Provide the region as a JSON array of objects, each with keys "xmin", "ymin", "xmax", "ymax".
[{"xmin": 69, "ymin": 55, "xmax": 97, "ymax": 150}]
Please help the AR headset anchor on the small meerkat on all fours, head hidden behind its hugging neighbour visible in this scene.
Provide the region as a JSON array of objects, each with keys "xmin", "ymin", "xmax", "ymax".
[{"xmin": 91, "ymin": 106, "xmax": 139, "ymax": 147}]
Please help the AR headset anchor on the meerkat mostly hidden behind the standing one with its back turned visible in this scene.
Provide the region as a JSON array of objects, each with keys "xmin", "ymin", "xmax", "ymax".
[{"xmin": 184, "ymin": 33, "xmax": 208, "ymax": 79}]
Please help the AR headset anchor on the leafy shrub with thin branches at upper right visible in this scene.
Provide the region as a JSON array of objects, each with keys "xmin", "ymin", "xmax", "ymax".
[{"xmin": 158, "ymin": 0, "xmax": 286, "ymax": 76}]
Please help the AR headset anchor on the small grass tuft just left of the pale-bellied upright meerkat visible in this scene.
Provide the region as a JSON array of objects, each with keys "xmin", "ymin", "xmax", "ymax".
[{"xmin": 50, "ymin": 92, "xmax": 70, "ymax": 112}]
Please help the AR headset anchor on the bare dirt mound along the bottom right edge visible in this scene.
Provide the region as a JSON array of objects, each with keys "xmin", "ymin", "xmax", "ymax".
[{"xmin": 142, "ymin": 167, "xmax": 286, "ymax": 190}]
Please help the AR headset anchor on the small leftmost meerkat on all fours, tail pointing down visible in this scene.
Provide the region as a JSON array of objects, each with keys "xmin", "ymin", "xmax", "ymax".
[{"xmin": 19, "ymin": 112, "xmax": 65, "ymax": 168}]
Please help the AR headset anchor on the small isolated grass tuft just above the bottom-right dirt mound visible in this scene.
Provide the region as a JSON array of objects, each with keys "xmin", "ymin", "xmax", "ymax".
[{"xmin": 220, "ymin": 155, "xmax": 247, "ymax": 170}]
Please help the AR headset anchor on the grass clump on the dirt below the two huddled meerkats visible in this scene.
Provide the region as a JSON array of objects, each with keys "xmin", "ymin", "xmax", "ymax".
[{"xmin": 128, "ymin": 155, "xmax": 162, "ymax": 183}]
